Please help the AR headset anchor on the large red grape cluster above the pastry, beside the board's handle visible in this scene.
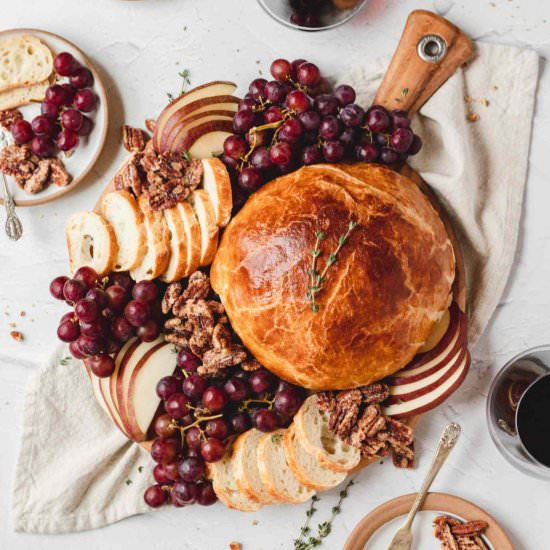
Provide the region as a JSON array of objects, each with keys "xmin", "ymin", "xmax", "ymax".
[{"xmin": 222, "ymin": 59, "xmax": 422, "ymax": 207}]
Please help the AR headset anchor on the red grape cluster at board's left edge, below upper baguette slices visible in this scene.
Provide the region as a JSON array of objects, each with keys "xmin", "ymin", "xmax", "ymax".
[{"xmin": 50, "ymin": 267, "xmax": 162, "ymax": 378}]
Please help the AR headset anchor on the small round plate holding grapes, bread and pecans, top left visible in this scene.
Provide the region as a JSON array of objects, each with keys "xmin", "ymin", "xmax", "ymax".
[{"xmin": 0, "ymin": 29, "xmax": 109, "ymax": 206}]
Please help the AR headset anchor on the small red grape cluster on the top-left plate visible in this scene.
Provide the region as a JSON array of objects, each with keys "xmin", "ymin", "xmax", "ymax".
[{"xmin": 11, "ymin": 52, "xmax": 97, "ymax": 157}]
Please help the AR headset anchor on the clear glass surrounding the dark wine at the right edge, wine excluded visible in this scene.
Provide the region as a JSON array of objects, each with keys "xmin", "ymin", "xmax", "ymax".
[{"xmin": 487, "ymin": 346, "xmax": 550, "ymax": 479}]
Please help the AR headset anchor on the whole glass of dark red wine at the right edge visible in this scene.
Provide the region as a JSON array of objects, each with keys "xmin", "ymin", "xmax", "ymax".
[{"xmin": 487, "ymin": 346, "xmax": 550, "ymax": 480}]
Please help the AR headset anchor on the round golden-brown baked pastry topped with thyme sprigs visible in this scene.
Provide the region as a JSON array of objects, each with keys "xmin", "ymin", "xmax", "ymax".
[{"xmin": 211, "ymin": 164, "xmax": 455, "ymax": 390}]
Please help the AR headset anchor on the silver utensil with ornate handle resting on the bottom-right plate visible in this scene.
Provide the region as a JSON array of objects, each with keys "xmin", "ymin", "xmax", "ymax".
[{"xmin": 388, "ymin": 422, "xmax": 461, "ymax": 550}]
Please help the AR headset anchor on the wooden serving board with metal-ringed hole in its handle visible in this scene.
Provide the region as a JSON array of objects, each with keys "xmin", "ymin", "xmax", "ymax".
[{"xmin": 355, "ymin": 10, "xmax": 474, "ymax": 470}]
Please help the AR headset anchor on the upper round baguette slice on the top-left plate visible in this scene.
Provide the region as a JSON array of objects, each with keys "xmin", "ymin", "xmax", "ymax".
[{"xmin": 0, "ymin": 35, "xmax": 53, "ymax": 92}]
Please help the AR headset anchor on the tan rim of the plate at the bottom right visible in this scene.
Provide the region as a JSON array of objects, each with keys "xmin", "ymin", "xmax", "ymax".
[{"xmin": 343, "ymin": 493, "xmax": 514, "ymax": 550}]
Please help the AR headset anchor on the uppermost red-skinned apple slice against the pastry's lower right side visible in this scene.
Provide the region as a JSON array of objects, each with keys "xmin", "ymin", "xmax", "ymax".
[{"xmin": 388, "ymin": 304, "xmax": 467, "ymax": 386}]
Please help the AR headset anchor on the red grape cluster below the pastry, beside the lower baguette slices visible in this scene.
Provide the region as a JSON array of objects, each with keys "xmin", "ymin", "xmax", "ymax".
[{"xmin": 144, "ymin": 349, "xmax": 304, "ymax": 507}]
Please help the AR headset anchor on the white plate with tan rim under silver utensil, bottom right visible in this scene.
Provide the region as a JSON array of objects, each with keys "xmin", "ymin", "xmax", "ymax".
[{"xmin": 344, "ymin": 493, "xmax": 514, "ymax": 550}]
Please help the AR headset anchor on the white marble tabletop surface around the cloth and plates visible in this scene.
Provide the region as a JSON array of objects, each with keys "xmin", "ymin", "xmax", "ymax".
[{"xmin": 0, "ymin": 0, "xmax": 550, "ymax": 550}]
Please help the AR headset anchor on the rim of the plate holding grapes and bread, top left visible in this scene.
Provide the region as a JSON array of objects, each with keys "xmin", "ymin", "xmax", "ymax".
[{"xmin": 0, "ymin": 27, "xmax": 109, "ymax": 207}]
